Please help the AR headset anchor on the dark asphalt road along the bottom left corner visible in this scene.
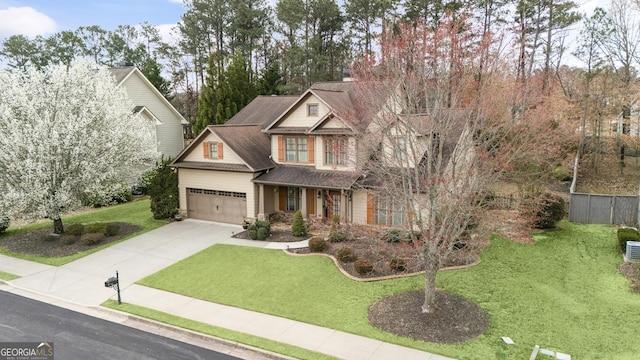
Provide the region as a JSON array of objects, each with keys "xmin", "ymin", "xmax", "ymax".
[{"xmin": 0, "ymin": 291, "xmax": 238, "ymax": 360}]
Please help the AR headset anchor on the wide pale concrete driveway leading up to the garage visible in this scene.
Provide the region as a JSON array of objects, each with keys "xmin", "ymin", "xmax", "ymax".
[{"xmin": 9, "ymin": 219, "xmax": 240, "ymax": 305}]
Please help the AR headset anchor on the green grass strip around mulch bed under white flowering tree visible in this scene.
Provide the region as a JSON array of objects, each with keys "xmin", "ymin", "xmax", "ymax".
[{"xmin": 0, "ymin": 198, "xmax": 167, "ymax": 266}]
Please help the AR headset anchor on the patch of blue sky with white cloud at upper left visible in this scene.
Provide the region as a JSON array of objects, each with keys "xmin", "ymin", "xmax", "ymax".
[{"xmin": 0, "ymin": 0, "xmax": 184, "ymax": 40}]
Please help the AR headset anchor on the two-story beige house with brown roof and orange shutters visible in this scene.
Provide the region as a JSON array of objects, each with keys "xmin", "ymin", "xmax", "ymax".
[{"xmin": 172, "ymin": 81, "xmax": 468, "ymax": 226}]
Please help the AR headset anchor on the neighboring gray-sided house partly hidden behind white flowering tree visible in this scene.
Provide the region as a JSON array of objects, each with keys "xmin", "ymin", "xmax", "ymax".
[{"xmin": 110, "ymin": 66, "xmax": 188, "ymax": 158}]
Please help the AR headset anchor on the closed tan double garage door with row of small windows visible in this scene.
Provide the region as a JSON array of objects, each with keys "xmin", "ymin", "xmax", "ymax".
[{"xmin": 187, "ymin": 188, "xmax": 247, "ymax": 224}]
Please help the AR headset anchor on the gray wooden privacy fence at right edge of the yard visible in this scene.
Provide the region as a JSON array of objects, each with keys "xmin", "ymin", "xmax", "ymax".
[{"xmin": 569, "ymin": 193, "xmax": 638, "ymax": 226}]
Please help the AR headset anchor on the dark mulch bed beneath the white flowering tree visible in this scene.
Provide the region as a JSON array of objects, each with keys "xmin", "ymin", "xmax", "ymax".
[{"xmin": 0, "ymin": 222, "xmax": 142, "ymax": 257}]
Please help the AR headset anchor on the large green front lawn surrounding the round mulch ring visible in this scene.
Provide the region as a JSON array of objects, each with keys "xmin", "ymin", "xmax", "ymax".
[{"xmin": 140, "ymin": 222, "xmax": 640, "ymax": 359}]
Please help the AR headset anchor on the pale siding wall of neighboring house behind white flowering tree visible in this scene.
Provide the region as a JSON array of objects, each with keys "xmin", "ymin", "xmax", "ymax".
[{"xmin": 122, "ymin": 71, "xmax": 184, "ymax": 157}]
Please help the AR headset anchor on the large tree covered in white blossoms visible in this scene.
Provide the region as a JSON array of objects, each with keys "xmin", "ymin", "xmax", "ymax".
[{"xmin": 0, "ymin": 61, "xmax": 157, "ymax": 234}]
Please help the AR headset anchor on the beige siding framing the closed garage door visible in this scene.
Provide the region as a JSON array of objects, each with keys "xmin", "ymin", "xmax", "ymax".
[{"xmin": 178, "ymin": 169, "xmax": 258, "ymax": 218}]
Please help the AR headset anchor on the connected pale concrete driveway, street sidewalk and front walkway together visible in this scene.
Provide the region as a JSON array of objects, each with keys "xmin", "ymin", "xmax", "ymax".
[{"xmin": 0, "ymin": 219, "xmax": 449, "ymax": 360}]
